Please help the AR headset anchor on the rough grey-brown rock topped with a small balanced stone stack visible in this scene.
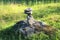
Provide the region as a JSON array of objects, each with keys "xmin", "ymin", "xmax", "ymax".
[{"xmin": 17, "ymin": 8, "xmax": 55, "ymax": 36}]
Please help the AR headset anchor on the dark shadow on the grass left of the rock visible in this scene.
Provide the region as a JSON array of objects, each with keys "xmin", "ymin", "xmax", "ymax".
[{"xmin": 0, "ymin": 23, "xmax": 26, "ymax": 40}]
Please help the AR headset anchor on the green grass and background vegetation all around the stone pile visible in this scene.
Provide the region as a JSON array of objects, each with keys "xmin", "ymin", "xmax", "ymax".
[{"xmin": 0, "ymin": 0, "xmax": 60, "ymax": 40}]
